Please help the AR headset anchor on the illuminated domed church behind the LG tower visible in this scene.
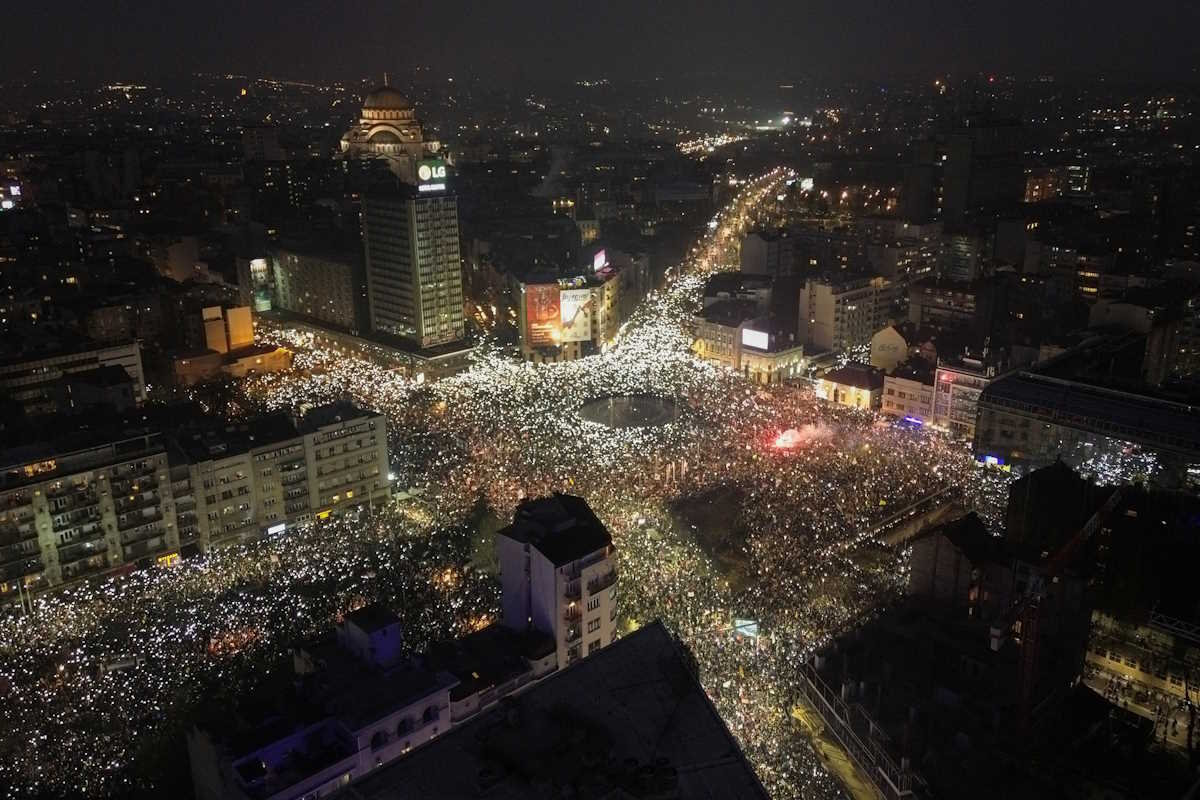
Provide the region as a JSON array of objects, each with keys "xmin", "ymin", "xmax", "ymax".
[{"xmin": 342, "ymin": 77, "xmax": 440, "ymax": 184}]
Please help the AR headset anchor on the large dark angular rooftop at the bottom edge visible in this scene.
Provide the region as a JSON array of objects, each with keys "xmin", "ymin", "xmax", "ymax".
[{"xmin": 336, "ymin": 622, "xmax": 767, "ymax": 800}]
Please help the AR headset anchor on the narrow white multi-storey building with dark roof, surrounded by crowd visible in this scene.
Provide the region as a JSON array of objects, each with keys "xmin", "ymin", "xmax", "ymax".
[{"xmin": 496, "ymin": 494, "xmax": 617, "ymax": 668}]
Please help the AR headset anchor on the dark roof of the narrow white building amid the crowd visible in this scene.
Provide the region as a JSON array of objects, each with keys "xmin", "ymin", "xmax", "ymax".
[{"xmin": 500, "ymin": 493, "xmax": 612, "ymax": 566}]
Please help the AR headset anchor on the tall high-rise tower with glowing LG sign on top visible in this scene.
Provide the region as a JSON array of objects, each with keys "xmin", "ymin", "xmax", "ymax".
[{"xmin": 362, "ymin": 179, "xmax": 466, "ymax": 348}]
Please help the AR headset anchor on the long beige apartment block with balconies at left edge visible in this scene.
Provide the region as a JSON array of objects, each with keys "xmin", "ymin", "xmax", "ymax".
[{"xmin": 0, "ymin": 403, "xmax": 390, "ymax": 602}]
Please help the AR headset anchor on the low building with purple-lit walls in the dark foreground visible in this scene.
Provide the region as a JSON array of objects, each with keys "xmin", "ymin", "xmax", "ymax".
[{"xmin": 187, "ymin": 606, "xmax": 457, "ymax": 800}]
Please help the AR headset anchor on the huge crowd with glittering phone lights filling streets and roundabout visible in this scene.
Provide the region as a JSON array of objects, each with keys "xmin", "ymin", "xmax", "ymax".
[{"xmin": 0, "ymin": 165, "xmax": 1007, "ymax": 798}]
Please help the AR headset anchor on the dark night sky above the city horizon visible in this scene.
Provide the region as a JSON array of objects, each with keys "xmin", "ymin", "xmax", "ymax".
[{"xmin": 0, "ymin": 0, "xmax": 1200, "ymax": 80}]
